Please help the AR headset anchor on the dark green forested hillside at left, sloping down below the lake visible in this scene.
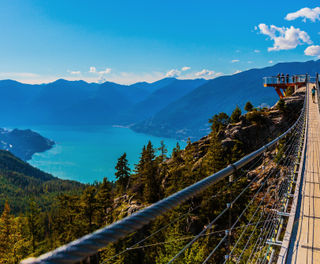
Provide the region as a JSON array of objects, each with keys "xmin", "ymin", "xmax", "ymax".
[{"xmin": 0, "ymin": 150, "xmax": 84, "ymax": 215}]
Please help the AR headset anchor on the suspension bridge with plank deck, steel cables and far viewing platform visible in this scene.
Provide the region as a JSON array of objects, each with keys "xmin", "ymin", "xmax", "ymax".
[{"xmin": 22, "ymin": 76, "xmax": 320, "ymax": 264}]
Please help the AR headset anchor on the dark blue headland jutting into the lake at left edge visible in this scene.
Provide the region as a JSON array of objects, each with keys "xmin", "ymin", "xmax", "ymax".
[{"xmin": 0, "ymin": 128, "xmax": 55, "ymax": 161}]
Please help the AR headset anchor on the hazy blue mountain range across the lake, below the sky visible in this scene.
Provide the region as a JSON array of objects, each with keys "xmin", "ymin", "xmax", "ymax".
[{"xmin": 0, "ymin": 60, "xmax": 320, "ymax": 140}]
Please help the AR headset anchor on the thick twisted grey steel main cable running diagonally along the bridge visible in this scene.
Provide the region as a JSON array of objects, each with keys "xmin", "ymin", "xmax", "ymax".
[{"xmin": 21, "ymin": 96, "xmax": 305, "ymax": 264}]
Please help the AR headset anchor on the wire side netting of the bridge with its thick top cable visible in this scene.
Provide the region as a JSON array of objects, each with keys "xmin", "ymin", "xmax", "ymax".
[{"xmin": 24, "ymin": 91, "xmax": 304, "ymax": 263}]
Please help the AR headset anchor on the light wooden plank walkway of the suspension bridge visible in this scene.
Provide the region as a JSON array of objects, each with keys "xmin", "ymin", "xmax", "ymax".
[{"xmin": 287, "ymin": 84, "xmax": 320, "ymax": 264}]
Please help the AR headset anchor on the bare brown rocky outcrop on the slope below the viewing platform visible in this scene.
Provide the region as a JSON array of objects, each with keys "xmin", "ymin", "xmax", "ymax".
[{"xmin": 172, "ymin": 88, "xmax": 305, "ymax": 169}]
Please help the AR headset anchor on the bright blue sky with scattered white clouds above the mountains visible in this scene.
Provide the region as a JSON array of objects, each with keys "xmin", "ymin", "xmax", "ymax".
[{"xmin": 0, "ymin": 0, "xmax": 320, "ymax": 84}]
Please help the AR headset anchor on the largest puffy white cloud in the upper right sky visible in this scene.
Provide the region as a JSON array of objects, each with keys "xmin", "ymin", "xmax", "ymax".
[{"xmin": 258, "ymin": 24, "xmax": 312, "ymax": 51}]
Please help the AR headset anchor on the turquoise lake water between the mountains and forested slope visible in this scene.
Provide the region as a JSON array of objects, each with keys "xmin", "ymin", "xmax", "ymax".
[{"xmin": 24, "ymin": 126, "xmax": 185, "ymax": 183}]
